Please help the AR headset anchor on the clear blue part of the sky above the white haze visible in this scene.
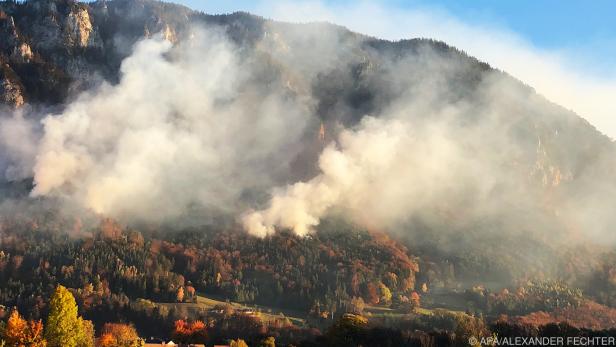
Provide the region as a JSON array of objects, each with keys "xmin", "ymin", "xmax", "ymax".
[{"xmin": 172, "ymin": 0, "xmax": 616, "ymax": 76}]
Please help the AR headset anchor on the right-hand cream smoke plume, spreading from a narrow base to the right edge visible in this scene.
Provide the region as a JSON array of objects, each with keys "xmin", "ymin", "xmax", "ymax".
[{"xmin": 242, "ymin": 43, "xmax": 615, "ymax": 246}]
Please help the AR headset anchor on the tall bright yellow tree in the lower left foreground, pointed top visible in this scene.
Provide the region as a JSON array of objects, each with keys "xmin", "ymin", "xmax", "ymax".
[{"xmin": 45, "ymin": 285, "xmax": 94, "ymax": 347}]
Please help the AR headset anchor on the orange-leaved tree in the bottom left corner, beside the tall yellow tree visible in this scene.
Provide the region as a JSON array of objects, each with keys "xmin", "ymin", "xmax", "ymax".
[{"xmin": 2, "ymin": 309, "xmax": 47, "ymax": 347}]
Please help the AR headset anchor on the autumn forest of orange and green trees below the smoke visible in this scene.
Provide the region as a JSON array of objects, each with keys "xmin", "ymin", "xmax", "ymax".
[{"xmin": 0, "ymin": 214, "xmax": 616, "ymax": 346}]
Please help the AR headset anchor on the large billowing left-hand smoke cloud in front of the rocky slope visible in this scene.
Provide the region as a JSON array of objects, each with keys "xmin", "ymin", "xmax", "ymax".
[{"xmin": 26, "ymin": 29, "xmax": 308, "ymax": 222}]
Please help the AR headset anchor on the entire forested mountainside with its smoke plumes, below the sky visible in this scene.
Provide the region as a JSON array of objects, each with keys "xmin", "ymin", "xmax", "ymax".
[{"xmin": 0, "ymin": 0, "xmax": 616, "ymax": 346}]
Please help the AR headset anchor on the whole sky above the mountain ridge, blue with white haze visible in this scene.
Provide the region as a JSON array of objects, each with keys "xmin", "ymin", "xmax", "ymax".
[{"xmin": 170, "ymin": 0, "xmax": 616, "ymax": 139}]
